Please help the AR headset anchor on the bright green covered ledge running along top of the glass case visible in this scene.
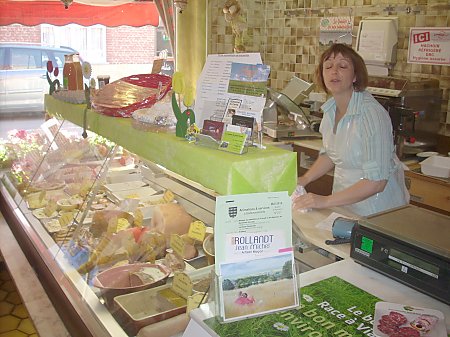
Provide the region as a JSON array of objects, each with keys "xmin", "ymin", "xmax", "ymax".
[{"xmin": 45, "ymin": 95, "xmax": 297, "ymax": 195}]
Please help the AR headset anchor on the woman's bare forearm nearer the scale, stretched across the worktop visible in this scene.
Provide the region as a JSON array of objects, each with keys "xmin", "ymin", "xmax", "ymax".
[{"xmin": 292, "ymin": 179, "xmax": 387, "ymax": 209}]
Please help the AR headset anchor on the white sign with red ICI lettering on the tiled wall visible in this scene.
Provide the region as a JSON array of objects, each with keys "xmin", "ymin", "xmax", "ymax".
[{"xmin": 408, "ymin": 27, "xmax": 450, "ymax": 66}]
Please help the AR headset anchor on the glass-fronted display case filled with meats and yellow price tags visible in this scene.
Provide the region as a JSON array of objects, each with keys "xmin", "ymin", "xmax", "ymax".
[{"xmin": 0, "ymin": 119, "xmax": 215, "ymax": 337}]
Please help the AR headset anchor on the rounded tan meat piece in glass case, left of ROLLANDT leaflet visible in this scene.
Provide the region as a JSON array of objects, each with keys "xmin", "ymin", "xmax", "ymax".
[{"xmin": 151, "ymin": 203, "xmax": 194, "ymax": 246}]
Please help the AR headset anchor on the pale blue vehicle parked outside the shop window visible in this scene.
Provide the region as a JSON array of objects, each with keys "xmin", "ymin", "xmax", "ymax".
[{"xmin": 0, "ymin": 43, "xmax": 77, "ymax": 115}]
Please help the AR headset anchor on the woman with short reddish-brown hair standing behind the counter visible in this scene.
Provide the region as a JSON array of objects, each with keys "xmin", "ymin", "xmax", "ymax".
[{"xmin": 293, "ymin": 44, "xmax": 409, "ymax": 216}]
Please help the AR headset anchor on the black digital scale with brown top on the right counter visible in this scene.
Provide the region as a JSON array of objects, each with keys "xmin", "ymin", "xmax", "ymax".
[{"xmin": 350, "ymin": 205, "xmax": 450, "ymax": 304}]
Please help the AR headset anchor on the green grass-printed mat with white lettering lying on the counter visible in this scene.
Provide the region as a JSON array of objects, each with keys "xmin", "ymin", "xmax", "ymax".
[{"xmin": 204, "ymin": 276, "xmax": 380, "ymax": 337}]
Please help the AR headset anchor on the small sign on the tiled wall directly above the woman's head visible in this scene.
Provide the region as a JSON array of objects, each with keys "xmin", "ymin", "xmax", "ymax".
[{"xmin": 319, "ymin": 16, "xmax": 353, "ymax": 46}]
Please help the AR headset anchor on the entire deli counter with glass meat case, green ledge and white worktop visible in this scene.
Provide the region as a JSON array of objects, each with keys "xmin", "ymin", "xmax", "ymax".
[{"xmin": 0, "ymin": 96, "xmax": 449, "ymax": 337}]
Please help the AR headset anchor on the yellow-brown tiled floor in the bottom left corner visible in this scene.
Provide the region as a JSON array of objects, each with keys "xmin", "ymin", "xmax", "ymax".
[{"xmin": 0, "ymin": 261, "xmax": 39, "ymax": 337}]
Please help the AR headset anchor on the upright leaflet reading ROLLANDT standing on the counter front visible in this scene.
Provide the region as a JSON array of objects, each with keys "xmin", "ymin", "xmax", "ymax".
[{"xmin": 214, "ymin": 192, "xmax": 299, "ymax": 322}]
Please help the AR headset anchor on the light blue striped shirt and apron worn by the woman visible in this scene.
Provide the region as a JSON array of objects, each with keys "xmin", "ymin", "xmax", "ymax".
[{"xmin": 320, "ymin": 91, "xmax": 409, "ymax": 216}]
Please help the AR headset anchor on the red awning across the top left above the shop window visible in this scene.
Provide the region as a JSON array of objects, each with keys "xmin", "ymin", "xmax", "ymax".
[{"xmin": 0, "ymin": 0, "xmax": 159, "ymax": 27}]
